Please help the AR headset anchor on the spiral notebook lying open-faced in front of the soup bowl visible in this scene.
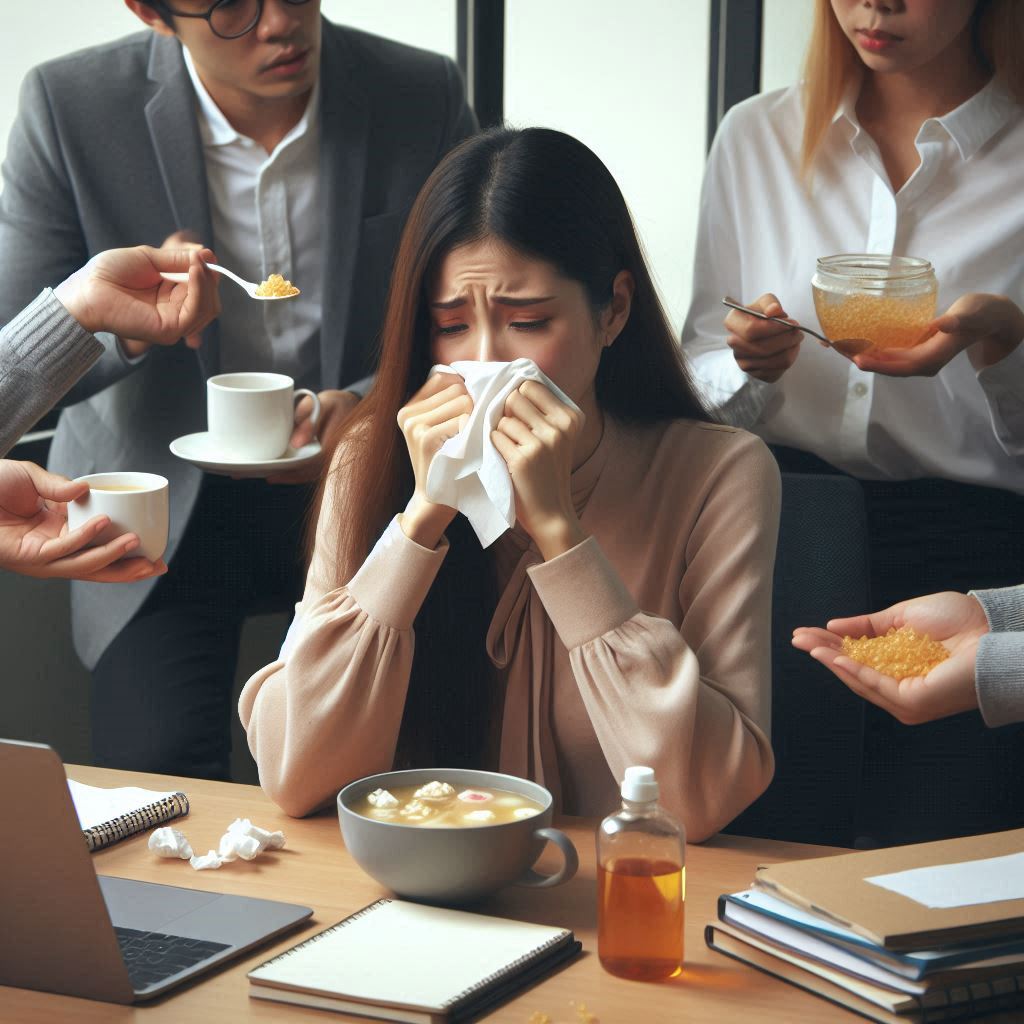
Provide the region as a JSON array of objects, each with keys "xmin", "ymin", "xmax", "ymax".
[{"xmin": 249, "ymin": 899, "xmax": 581, "ymax": 1024}]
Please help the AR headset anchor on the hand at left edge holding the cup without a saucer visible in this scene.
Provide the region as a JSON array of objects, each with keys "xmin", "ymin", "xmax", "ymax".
[{"xmin": 0, "ymin": 459, "xmax": 167, "ymax": 583}]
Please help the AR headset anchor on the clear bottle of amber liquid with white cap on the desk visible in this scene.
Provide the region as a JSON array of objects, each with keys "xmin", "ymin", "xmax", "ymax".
[{"xmin": 597, "ymin": 766, "xmax": 686, "ymax": 981}]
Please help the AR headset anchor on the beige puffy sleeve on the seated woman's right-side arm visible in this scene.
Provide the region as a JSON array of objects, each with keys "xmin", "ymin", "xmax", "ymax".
[{"xmin": 529, "ymin": 433, "xmax": 779, "ymax": 842}]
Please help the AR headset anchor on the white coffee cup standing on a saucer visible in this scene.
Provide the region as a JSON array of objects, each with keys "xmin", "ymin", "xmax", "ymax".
[{"xmin": 206, "ymin": 373, "xmax": 319, "ymax": 462}]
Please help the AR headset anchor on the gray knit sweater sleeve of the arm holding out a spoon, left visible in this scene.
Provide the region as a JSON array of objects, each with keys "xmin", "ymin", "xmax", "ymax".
[{"xmin": 0, "ymin": 288, "xmax": 103, "ymax": 458}]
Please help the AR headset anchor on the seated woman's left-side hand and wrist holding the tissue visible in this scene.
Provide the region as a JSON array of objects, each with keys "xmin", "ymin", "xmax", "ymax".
[{"xmin": 398, "ymin": 374, "xmax": 473, "ymax": 548}]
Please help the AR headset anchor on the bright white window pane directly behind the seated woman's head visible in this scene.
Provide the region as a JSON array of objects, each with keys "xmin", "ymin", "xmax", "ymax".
[{"xmin": 505, "ymin": 0, "xmax": 710, "ymax": 333}]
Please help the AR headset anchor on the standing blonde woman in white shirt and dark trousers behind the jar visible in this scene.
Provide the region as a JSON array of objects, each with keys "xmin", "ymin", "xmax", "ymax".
[{"xmin": 683, "ymin": 0, "xmax": 1024, "ymax": 843}]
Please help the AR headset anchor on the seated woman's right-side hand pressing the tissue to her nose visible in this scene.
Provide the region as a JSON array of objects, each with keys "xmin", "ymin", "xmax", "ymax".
[{"xmin": 490, "ymin": 381, "xmax": 586, "ymax": 561}]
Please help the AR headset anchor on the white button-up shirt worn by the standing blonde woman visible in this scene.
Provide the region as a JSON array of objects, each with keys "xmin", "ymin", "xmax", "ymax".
[{"xmin": 683, "ymin": 82, "xmax": 1024, "ymax": 494}]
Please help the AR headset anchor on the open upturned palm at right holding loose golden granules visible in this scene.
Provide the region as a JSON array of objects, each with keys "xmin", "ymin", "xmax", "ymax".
[{"xmin": 793, "ymin": 592, "xmax": 988, "ymax": 725}]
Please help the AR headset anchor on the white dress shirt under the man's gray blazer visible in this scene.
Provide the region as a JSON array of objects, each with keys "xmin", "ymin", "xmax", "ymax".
[{"xmin": 184, "ymin": 49, "xmax": 324, "ymax": 390}]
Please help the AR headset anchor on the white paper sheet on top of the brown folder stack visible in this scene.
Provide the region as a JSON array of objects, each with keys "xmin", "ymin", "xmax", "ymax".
[{"xmin": 864, "ymin": 853, "xmax": 1024, "ymax": 909}]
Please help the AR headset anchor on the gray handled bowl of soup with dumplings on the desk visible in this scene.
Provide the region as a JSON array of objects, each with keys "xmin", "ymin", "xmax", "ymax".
[{"xmin": 338, "ymin": 768, "xmax": 579, "ymax": 905}]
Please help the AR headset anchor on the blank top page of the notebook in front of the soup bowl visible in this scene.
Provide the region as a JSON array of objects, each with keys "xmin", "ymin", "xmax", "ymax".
[{"xmin": 249, "ymin": 900, "xmax": 568, "ymax": 1009}]
